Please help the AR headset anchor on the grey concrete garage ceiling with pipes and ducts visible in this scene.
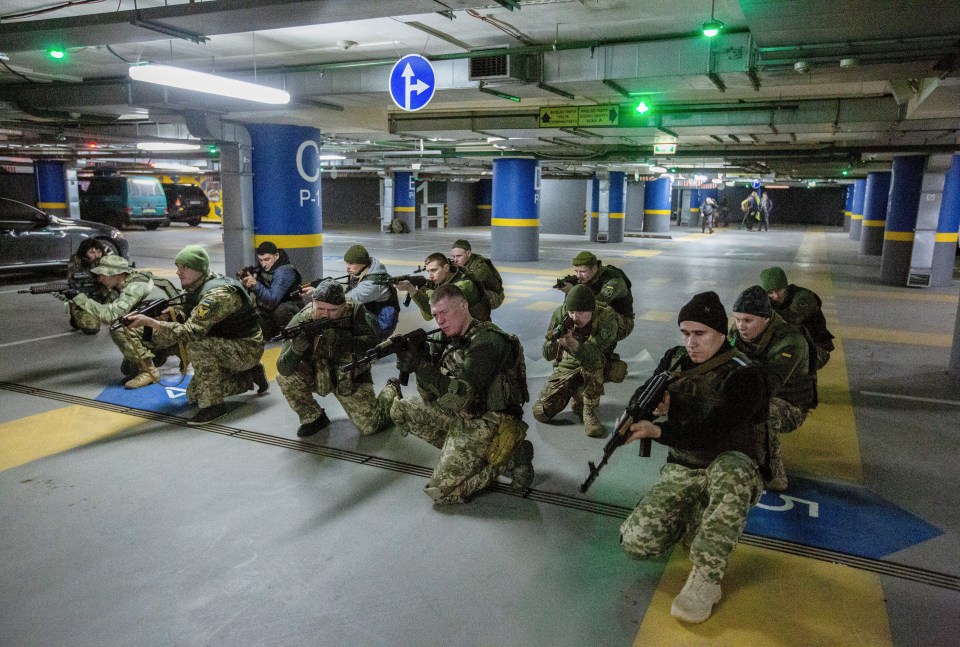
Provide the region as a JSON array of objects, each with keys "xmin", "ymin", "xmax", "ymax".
[{"xmin": 0, "ymin": 0, "xmax": 960, "ymax": 180}]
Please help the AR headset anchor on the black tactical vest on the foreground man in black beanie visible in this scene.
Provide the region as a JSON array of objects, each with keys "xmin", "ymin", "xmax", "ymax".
[{"xmin": 667, "ymin": 346, "xmax": 768, "ymax": 468}]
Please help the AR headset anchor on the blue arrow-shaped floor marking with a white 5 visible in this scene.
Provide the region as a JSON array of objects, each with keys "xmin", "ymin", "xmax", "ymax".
[{"xmin": 746, "ymin": 476, "xmax": 943, "ymax": 559}]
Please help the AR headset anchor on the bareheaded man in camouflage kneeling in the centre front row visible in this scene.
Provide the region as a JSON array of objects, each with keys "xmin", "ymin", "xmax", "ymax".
[{"xmin": 384, "ymin": 284, "xmax": 534, "ymax": 504}]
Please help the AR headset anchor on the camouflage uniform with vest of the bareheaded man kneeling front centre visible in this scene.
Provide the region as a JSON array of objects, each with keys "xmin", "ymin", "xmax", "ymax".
[{"xmin": 390, "ymin": 321, "xmax": 526, "ymax": 504}]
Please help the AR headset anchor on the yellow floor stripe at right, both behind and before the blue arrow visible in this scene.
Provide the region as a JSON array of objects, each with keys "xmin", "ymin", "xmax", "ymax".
[{"xmin": 633, "ymin": 231, "xmax": 892, "ymax": 647}]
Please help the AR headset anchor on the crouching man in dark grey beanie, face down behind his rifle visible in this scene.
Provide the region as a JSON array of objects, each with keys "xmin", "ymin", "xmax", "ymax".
[{"xmin": 277, "ymin": 279, "xmax": 390, "ymax": 438}]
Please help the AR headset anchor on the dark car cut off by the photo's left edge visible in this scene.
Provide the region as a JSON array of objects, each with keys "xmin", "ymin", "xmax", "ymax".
[{"xmin": 0, "ymin": 198, "xmax": 129, "ymax": 270}]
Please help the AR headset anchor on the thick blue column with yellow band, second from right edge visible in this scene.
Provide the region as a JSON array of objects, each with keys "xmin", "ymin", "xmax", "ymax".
[{"xmin": 880, "ymin": 155, "xmax": 927, "ymax": 285}]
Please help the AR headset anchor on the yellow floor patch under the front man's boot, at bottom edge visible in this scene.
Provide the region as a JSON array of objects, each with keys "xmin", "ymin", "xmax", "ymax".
[{"xmin": 633, "ymin": 545, "xmax": 893, "ymax": 647}]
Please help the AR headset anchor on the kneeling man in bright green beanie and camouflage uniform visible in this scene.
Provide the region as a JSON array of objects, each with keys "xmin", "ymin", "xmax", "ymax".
[{"xmin": 130, "ymin": 245, "xmax": 269, "ymax": 425}]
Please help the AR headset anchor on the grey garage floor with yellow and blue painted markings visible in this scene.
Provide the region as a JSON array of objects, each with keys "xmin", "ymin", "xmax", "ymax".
[{"xmin": 0, "ymin": 220, "xmax": 960, "ymax": 646}]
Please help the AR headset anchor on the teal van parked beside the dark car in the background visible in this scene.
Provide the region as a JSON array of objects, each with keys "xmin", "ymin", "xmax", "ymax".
[{"xmin": 80, "ymin": 175, "xmax": 170, "ymax": 229}]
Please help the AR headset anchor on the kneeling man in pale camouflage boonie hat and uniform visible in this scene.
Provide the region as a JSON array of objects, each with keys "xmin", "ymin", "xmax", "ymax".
[{"xmin": 62, "ymin": 255, "xmax": 176, "ymax": 389}]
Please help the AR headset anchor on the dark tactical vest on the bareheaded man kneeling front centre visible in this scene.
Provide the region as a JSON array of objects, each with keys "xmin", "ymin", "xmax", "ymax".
[{"xmin": 432, "ymin": 321, "xmax": 530, "ymax": 417}]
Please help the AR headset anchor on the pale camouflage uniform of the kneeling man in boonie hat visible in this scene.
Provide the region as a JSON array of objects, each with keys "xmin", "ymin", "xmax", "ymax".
[{"xmin": 72, "ymin": 271, "xmax": 176, "ymax": 367}]
